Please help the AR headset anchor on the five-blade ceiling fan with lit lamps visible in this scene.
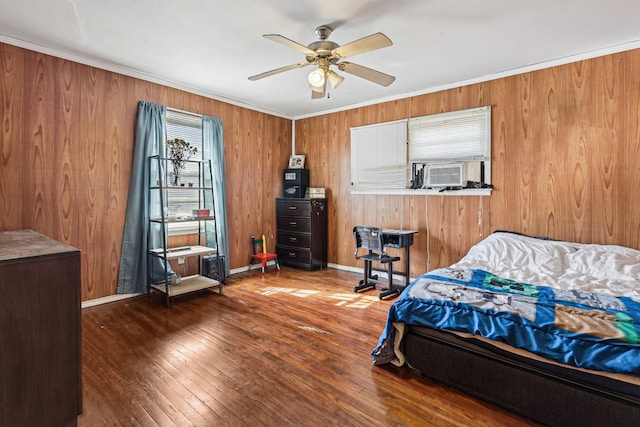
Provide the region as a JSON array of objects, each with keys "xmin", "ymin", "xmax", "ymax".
[{"xmin": 249, "ymin": 25, "xmax": 396, "ymax": 99}]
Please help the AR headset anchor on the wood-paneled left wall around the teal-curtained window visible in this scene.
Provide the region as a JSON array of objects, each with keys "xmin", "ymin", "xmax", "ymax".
[{"xmin": 0, "ymin": 43, "xmax": 291, "ymax": 300}]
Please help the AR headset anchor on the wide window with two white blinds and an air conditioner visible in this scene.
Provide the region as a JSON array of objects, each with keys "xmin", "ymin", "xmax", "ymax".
[{"xmin": 351, "ymin": 106, "xmax": 491, "ymax": 194}]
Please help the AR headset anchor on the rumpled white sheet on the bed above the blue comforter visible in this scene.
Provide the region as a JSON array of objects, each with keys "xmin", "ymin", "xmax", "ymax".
[{"xmin": 451, "ymin": 232, "xmax": 640, "ymax": 302}]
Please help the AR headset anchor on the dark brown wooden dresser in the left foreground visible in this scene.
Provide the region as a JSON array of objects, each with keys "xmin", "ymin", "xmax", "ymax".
[{"xmin": 0, "ymin": 230, "xmax": 82, "ymax": 427}]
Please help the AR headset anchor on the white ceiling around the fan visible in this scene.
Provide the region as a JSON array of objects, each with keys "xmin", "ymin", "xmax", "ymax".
[{"xmin": 0, "ymin": 0, "xmax": 640, "ymax": 119}]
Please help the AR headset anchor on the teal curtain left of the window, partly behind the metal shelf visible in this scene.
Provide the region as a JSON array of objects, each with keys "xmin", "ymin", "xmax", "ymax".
[{"xmin": 116, "ymin": 101, "xmax": 167, "ymax": 294}]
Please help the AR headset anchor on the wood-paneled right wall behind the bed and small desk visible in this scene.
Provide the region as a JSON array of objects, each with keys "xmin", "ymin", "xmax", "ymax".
[{"xmin": 296, "ymin": 50, "xmax": 640, "ymax": 276}]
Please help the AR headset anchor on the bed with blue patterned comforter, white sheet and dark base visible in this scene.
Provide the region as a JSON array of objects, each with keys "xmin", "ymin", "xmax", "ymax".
[{"xmin": 372, "ymin": 231, "xmax": 640, "ymax": 426}]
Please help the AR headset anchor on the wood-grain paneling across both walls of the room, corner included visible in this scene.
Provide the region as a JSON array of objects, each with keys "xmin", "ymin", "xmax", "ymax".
[{"xmin": 0, "ymin": 44, "xmax": 640, "ymax": 300}]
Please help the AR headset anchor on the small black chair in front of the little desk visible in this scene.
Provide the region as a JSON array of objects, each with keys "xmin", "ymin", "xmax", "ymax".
[{"xmin": 353, "ymin": 225, "xmax": 400, "ymax": 299}]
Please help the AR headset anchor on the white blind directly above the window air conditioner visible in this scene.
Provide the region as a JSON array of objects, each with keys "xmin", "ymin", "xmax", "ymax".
[{"xmin": 409, "ymin": 106, "xmax": 491, "ymax": 164}]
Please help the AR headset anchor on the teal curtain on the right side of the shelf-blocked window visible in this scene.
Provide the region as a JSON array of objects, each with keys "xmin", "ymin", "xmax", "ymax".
[{"xmin": 202, "ymin": 116, "xmax": 229, "ymax": 277}]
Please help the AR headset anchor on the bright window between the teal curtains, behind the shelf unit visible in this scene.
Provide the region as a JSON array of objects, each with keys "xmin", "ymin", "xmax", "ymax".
[{"xmin": 166, "ymin": 109, "xmax": 203, "ymax": 235}]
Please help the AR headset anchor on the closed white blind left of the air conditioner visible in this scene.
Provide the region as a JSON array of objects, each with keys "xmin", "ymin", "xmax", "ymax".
[{"xmin": 351, "ymin": 120, "xmax": 407, "ymax": 190}]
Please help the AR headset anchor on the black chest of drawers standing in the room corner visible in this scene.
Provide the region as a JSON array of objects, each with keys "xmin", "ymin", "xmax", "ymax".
[{"xmin": 276, "ymin": 198, "xmax": 328, "ymax": 270}]
